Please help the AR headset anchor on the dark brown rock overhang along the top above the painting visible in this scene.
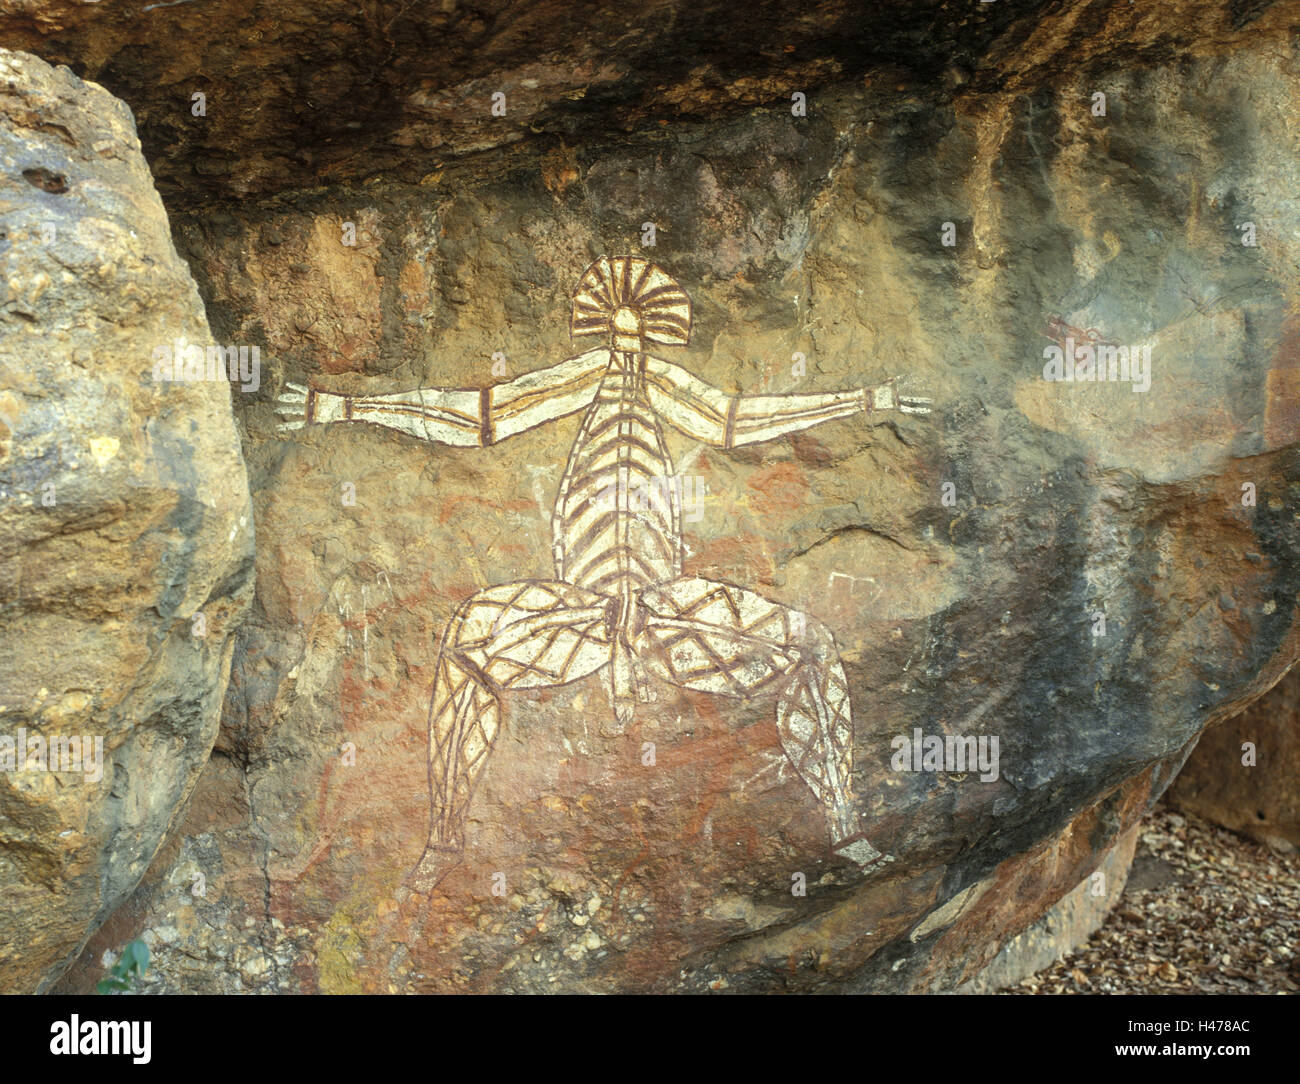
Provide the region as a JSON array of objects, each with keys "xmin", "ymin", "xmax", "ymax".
[{"xmin": 0, "ymin": 0, "xmax": 1296, "ymax": 205}]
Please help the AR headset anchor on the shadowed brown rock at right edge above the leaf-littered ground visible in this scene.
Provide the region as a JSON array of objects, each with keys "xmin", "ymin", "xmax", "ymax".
[{"xmin": 1169, "ymin": 669, "xmax": 1300, "ymax": 851}]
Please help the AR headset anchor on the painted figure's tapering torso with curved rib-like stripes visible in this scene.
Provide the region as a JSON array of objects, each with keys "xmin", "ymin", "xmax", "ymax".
[{"xmin": 551, "ymin": 351, "xmax": 681, "ymax": 597}]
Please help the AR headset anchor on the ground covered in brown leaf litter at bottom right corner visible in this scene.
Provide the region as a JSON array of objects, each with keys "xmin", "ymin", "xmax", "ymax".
[{"xmin": 1004, "ymin": 805, "xmax": 1300, "ymax": 994}]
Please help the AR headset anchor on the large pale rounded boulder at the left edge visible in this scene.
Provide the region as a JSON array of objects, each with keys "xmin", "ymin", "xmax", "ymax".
[{"xmin": 0, "ymin": 51, "xmax": 252, "ymax": 993}]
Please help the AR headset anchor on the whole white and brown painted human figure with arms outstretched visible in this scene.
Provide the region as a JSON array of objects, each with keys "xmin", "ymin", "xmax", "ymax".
[{"xmin": 278, "ymin": 256, "xmax": 930, "ymax": 892}]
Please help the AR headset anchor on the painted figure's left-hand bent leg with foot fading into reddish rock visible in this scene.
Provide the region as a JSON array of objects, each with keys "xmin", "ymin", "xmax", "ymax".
[{"xmin": 411, "ymin": 581, "xmax": 616, "ymax": 892}]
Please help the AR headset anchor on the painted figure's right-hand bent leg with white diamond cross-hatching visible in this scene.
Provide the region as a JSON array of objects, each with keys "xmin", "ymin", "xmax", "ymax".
[{"xmin": 636, "ymin": 577, "xmax": 881, "ymax": 866}]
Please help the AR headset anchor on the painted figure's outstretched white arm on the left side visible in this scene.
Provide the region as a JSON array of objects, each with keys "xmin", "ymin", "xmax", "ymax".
[{"xmin": 276, "ymin": 348, "xmax": 610, "ymax": 447}]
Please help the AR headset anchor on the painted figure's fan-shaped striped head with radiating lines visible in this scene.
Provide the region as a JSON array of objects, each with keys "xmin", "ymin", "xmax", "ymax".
[{"xmin": 569, "ymin": 256, "xmax": 690, "ymax": 350}]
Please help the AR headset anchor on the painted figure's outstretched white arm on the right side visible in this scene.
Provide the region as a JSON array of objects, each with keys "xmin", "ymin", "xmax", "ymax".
[{"xmin": 646, "ymin": 357, "xmax": 930, "ymax": 448}]
